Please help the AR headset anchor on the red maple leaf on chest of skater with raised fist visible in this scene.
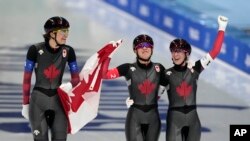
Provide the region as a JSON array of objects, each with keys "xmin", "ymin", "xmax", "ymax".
[{"xmin": 176, "ymin": 81, "xmax": 192, "ymax": 99}]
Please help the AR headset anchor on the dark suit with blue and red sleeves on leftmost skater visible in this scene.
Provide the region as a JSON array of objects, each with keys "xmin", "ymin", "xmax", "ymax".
[{"xmin": 23, "ymin": 42, "xmax": 79, "ymax": 141}]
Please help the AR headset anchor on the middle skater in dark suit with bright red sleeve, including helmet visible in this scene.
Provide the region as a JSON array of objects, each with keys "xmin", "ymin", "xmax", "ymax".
[{"xmin": 103, "ymin": 34, "xmax": 170, "ymax": 141}]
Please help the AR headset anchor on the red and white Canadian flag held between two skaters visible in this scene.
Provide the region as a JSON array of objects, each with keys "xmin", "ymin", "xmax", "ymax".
[{"xmin": 58, "ymin": 40, "xmax": 122, "ymax": 134}]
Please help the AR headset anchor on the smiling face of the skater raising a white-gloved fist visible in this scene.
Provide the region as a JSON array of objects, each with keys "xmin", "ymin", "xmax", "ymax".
[{"xmin": 171, "ymin": 49, "xmax": 188, "ymax": 65}]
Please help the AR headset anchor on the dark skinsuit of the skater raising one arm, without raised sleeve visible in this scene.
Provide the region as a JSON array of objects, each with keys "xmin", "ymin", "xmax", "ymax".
[{"xmin": 165, "ymin": 61, "xmax": 203, "ymax": 141}]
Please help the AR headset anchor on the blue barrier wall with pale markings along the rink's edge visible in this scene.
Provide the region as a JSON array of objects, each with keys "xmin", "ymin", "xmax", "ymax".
[{"xmin": 103, "ymin": 0, "xmax": 250, "ymax": 74}]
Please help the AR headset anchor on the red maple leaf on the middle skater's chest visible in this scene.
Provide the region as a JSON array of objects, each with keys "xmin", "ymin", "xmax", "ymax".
[{"xmin": 138, "ymin": 79, "xmax": 156, "ymax": 95}]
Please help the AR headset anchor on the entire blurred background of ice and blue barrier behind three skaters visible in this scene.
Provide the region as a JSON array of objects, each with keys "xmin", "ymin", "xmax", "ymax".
[{"xmin": 0, "ymin": 0, "xmax": 250, "ymax": 141}]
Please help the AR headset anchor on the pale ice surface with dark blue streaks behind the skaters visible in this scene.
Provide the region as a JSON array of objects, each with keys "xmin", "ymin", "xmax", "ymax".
[{"xmin": 0, "ymin": 0, "xmax": 250, "ymax": 141}]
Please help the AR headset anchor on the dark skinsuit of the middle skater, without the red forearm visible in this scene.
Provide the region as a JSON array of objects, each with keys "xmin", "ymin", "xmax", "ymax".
[{"xmin": 117, "ymin": 61, "xmax": 164, "ymax": 141}]
